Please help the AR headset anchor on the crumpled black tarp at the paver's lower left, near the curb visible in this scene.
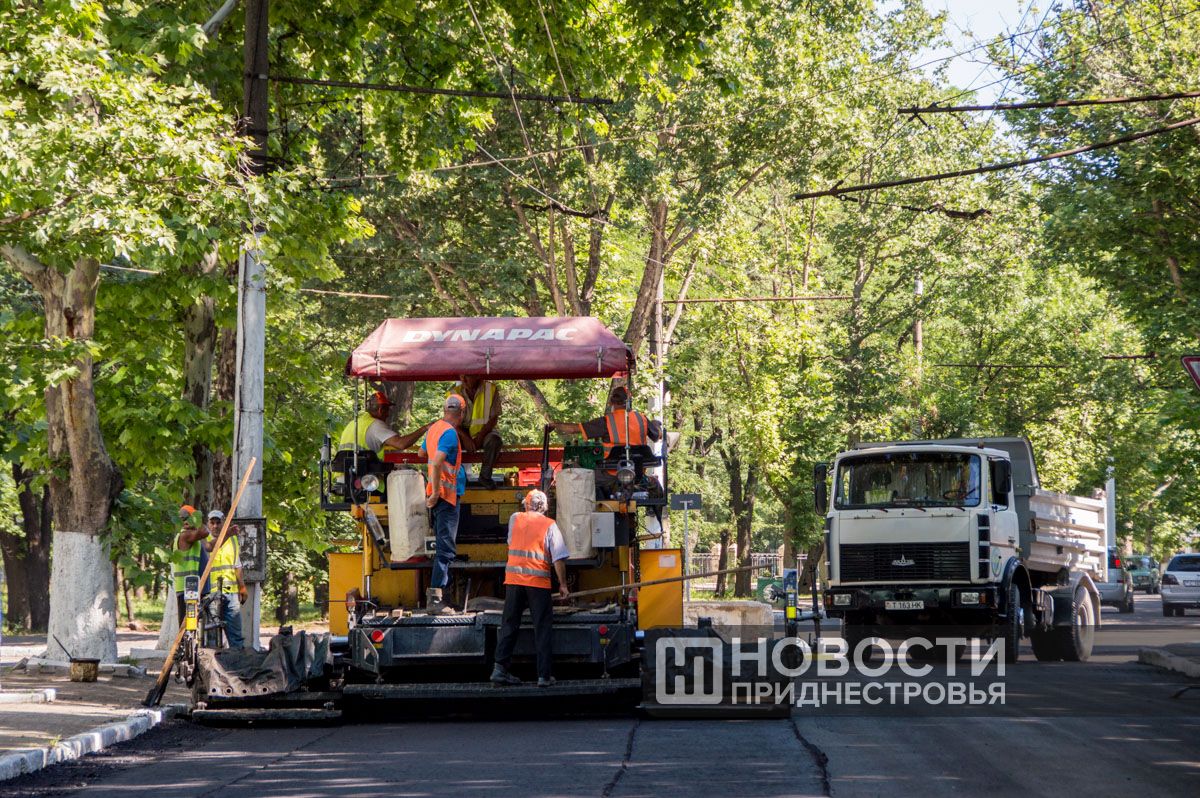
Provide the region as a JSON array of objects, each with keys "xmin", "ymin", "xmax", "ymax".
[{"xmin": 196, "ymin": 631, "xmax": 334, "ymax": 700}]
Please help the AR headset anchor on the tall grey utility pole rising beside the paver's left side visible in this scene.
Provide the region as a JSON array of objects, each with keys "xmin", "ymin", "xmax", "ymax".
[{"xmin": 233, "ymin": 0, "xmax": 269, "ymax": 648}]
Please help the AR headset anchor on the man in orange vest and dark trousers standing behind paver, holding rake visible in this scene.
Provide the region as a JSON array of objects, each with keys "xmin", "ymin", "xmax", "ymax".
[{"xmin": 491, "ymin": 491, "xmax": 571, "ymax": 688}]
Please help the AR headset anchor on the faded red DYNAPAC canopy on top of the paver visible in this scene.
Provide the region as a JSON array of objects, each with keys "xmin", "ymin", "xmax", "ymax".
[{"xmin": 346, "ymin": 316, "xmax": 632, "ymax": 382}]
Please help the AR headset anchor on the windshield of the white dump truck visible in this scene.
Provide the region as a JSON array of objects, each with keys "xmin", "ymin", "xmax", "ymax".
[{"xmin": 834, "ymin": 451, "xmax": 979, "ymax": 510}]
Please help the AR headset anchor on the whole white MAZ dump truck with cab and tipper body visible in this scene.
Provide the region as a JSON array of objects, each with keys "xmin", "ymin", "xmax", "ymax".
[{"xmin": 814, "ymin": 438, "xmax": 1111, "ymax": 662}]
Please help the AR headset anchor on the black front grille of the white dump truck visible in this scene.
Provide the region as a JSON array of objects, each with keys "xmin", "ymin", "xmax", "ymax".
[{"xmin": 838, "ymin": 542, "xmax": 971, "ymax": 582}]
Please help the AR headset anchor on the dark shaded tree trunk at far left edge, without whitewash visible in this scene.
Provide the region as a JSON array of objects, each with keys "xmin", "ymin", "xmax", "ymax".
[{"xmin": 0, "ymin": 463, "xmax": 52, "ymax": 631}]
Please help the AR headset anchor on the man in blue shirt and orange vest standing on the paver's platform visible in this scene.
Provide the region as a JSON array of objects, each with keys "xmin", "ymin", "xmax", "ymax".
[{"xmin": 421, "ymin": 394, "xmax": 467, "ymax": 613}]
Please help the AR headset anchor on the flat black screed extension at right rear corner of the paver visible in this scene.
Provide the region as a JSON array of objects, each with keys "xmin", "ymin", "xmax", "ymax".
[{"xmin": 641, "ymin": 626, "xmax": 799, "ymax": 719}]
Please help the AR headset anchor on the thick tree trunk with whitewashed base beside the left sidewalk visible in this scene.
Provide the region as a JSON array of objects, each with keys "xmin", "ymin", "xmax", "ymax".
[{"xmin": 0, "ymin": 246, "xmax": 124, "ymax": 662}]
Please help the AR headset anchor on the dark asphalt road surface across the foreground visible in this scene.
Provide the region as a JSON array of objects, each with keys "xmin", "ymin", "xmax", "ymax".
[{"xmin": 0, "ymin": 595, "xmax": 1200, "ymax": 798}]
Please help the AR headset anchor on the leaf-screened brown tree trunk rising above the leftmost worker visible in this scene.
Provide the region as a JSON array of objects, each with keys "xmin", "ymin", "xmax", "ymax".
[{"xmin": 184, "ymin": 248, "xmax": 220, "ymax": 509}]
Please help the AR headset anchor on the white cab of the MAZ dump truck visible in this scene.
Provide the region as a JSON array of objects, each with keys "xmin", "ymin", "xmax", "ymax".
[{"xmin": 826, "ymin": 444, "xmax": 1019, "ymax": 624}]
